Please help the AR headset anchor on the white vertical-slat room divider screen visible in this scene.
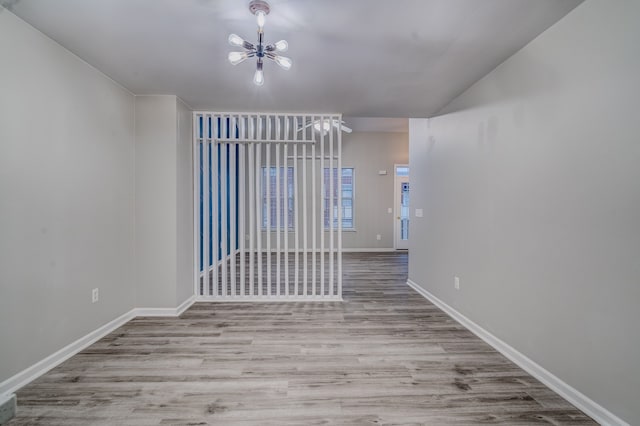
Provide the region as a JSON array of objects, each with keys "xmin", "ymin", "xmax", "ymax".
[{"xmin": 193, "ymin": 111, "xmax": 342, "ymax": 301}]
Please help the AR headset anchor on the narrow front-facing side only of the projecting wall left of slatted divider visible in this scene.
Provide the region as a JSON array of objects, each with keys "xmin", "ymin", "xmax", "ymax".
[{"xmin": 135, "ymin": 96, "xmax": 177, "ymax": 308}]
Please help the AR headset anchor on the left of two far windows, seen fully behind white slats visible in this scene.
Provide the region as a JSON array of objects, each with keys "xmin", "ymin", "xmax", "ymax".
[{"xmin": 260, "ymin": 167, "xmax": 294, "ymax": 229}]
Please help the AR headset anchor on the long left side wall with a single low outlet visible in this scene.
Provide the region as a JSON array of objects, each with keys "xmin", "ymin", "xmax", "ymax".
[{"xmin": 0, "ymin": 8, "xmax": 135, "ymax": 382}]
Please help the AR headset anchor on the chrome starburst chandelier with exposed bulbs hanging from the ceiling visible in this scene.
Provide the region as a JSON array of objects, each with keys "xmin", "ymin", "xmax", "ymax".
[{"xmin": 229, "ymin": 0, "xmax": 292, "ymax": 86}]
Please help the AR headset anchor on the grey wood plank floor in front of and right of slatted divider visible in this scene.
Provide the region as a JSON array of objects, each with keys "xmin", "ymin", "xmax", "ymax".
[{"xmin": 9, "ymin": 253, "xmax": 595, "ymax": 426}]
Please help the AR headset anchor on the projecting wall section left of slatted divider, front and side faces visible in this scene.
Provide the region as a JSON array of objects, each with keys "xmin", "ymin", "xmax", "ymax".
[{"xmin": 135, "ymin": 95, "xmax": 193, "ymax": 308}]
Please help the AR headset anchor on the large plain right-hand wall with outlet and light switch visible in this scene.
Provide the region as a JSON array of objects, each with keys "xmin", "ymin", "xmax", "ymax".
[{"xmin": 409, "ymin": 0, "xmax": 640, "ymax": 424}]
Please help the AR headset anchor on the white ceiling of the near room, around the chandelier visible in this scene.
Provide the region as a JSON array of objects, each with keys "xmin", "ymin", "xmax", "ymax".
[{"xmin": 0, "ymin": 0, "xmax": 582, "ymax": 117}]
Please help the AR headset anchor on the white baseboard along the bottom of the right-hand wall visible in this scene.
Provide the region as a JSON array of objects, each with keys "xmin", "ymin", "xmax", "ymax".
[{"xmin": 407, "ymin": 280, "xmax": 629, "ymax": 426}]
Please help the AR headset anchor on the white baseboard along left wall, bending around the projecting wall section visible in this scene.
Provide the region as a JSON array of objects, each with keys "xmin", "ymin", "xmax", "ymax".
[{"xmin": 0, "ymin": 295, "xmax": 196, "ymax": 399}]
